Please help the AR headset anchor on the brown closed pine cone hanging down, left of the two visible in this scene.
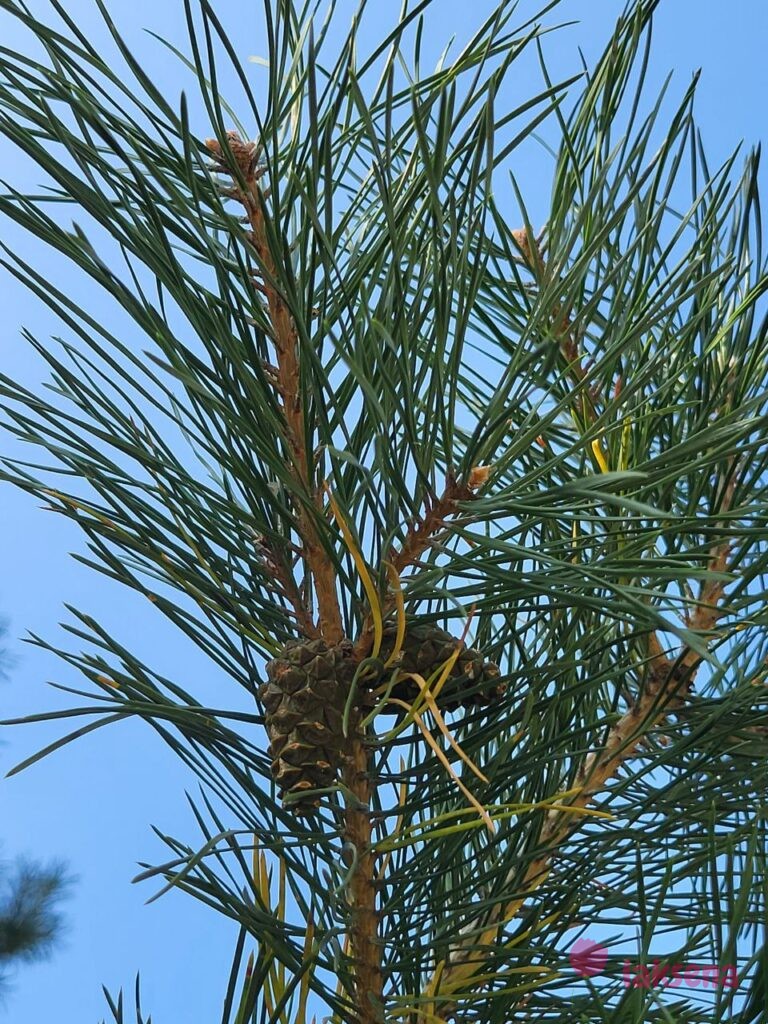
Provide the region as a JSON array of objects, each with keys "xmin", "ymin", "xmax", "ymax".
[{"xmin": 259, "ymin": 640, "xmax": 354, "ymax": 814}]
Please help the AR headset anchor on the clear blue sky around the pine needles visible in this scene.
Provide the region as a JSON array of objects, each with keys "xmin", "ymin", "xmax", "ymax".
[{"xmin": 0, "ymin": 0, "xmax": 768, "ymax": 1024}]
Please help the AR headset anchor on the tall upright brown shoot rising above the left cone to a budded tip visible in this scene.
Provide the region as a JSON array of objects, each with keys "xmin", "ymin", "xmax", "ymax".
[{"xmin": 206, "ymin": 131, "xmax": 344, "ymax": 644}]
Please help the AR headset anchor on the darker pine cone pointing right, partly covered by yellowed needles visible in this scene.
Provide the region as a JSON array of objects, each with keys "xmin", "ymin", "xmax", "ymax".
[{"xmin": 377, "ymin": 623, "xmax": 505, "ymax": 711}]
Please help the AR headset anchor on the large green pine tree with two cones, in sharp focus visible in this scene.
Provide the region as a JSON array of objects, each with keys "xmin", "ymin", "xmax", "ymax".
[{"xmin": 0, "ymin": 0, "xmax": 768, "ymax": 1024}]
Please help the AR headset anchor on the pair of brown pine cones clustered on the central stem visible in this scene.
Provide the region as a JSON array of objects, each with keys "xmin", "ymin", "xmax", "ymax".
[{"xmin": 259, "ymin": 623, "xmax": 504, "ymax": 814}]
